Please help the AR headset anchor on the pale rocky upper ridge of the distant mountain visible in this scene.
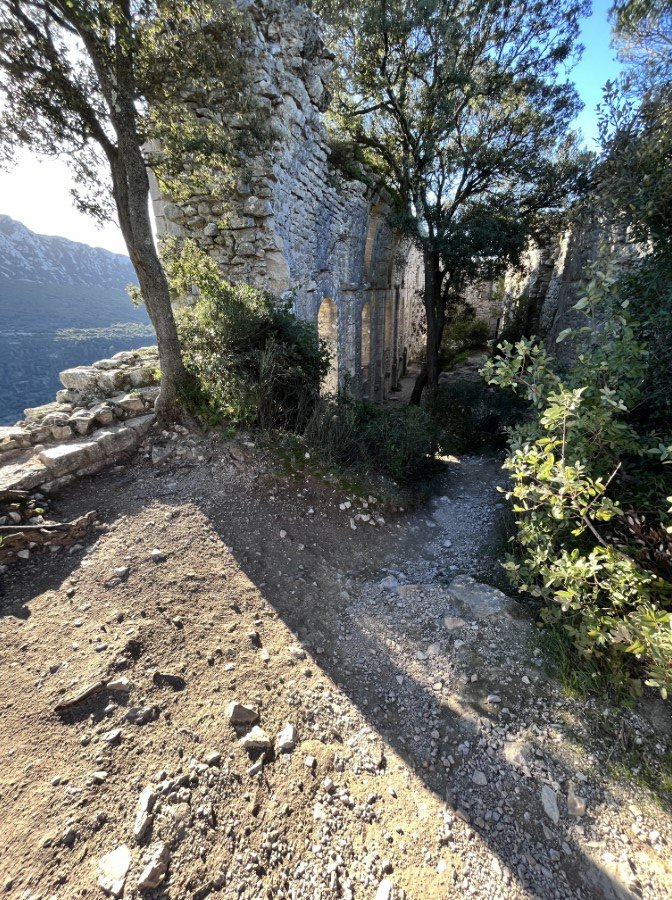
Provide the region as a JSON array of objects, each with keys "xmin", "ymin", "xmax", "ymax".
[{"xmin": 0, "ymin": 215, "xmax": 136, "ymax": 290}]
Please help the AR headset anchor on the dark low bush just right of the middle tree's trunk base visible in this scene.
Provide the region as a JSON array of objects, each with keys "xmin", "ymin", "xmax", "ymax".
[{"xmin": 427, "ymin": 378, "xmax": 529, "ymax": 454}]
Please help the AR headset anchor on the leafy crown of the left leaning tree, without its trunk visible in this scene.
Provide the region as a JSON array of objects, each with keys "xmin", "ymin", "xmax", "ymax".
[{"xmin": 0, "ymin": 0, "xmax": 251, "ymax": 220}]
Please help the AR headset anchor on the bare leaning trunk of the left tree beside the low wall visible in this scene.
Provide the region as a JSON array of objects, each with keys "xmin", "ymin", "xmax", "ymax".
[{"xmin": 112, "ymin": 128, "xmax": 187, "ymax": 423}]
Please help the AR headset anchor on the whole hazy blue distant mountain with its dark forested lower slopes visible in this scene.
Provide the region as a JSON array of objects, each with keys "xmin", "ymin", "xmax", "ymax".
[{"xmin": 0, "ymin": 216, "xmax": 156, "ymax": 425}]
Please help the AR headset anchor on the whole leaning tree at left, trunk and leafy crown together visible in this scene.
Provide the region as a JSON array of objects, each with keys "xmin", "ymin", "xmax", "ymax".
[{"xmin": 0, "ymin": 0, "xmax": 245, "ymax": 420}]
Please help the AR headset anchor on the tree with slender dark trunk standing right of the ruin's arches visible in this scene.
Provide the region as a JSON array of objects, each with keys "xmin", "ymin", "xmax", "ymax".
[{"xmin": 313, "ymin": 0, "xmax": 587, "ymax": 402}]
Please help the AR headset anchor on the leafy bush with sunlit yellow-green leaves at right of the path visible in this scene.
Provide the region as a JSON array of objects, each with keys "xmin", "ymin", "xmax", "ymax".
[{"xmin": 484, "ymin": 267, "xmax": 672, "ymax": 696}]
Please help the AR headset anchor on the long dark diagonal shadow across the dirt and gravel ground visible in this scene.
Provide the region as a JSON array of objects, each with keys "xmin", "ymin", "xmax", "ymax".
[{"xmin": 0, "ymin": 458, "xmax": 660, "ymax": 900}]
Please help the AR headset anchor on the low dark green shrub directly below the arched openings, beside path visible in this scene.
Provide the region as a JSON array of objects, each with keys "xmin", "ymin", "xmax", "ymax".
[{"xmin": 304, "ymin": 395, "xmax": 436, "ymax": 481}]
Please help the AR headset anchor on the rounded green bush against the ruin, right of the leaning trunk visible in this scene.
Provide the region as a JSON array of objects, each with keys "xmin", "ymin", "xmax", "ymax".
[{"xmin": 164, "ymin": 242, "xmax": 329, "ymax": 430}]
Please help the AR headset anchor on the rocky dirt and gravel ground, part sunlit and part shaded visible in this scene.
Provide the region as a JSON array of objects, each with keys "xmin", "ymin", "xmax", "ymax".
[{"xmin": 0, "ymin": 424, "xmax": 672, "ymax": 900}]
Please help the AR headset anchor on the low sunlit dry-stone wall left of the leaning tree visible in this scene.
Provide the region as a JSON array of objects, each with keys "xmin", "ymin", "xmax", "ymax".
[{"xmin": 0, "ymin": 347, "xmax": 159, "ymax": 500}]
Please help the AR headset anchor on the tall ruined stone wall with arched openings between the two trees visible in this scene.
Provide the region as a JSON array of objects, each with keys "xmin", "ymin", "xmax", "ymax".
[{"xmin": 153, "ymin": 0, "xmax": 422, "ymax": 399}]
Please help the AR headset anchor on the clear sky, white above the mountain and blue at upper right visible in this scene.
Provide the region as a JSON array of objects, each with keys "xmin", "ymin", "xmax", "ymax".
[{"xmin": 0, "ymin": 0, "xmax": 618, "ymax": 253}]
